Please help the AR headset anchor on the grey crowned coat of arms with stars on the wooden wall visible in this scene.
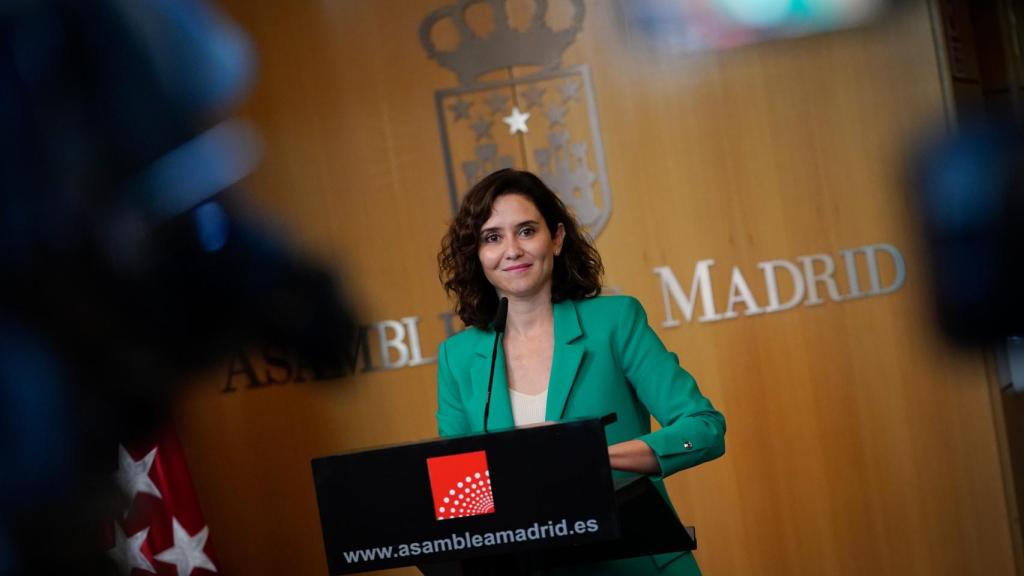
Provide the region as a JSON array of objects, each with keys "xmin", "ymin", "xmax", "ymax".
[{"xmin": 420, "ymin": 0, "xmax": 611, "ymax": 238}]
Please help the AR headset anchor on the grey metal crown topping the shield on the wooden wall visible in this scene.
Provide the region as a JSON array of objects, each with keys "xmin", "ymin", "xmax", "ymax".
[{"xmin": 420, "ymin": 0, "xmax": 585, "ymax": 85}]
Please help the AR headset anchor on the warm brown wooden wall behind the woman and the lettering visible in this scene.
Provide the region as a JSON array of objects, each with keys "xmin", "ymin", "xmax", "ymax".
[{"xmin": 178, "ymin": 0, "xmax": 1014, "ymax": 575}]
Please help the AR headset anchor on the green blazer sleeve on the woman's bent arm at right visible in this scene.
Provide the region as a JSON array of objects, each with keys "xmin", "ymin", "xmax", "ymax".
[{"xmin": 620, "ymin": 297, "xmax": 725, "ymax": 477}]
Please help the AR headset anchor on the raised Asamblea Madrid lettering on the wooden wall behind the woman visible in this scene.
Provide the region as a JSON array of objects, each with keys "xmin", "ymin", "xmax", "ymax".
[{"xmin": 222, "ymin": 239, "xmax": 906, "ymax": 393}]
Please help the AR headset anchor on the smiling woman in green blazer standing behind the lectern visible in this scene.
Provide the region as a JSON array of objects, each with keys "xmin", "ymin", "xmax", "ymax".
[{"xmin": 437, "ymin": 169, "xmax": 725, "ymax": 575}]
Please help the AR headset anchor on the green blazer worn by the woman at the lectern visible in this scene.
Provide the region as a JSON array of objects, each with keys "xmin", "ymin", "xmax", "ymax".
[{"xmin": 437, "ymin": 296, "xmax": 725, "ymax": 575}]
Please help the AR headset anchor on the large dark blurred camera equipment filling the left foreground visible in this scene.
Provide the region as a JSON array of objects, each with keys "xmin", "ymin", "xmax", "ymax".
[{"xmin": 0, "ymin": 0, "xmax": 355, "ymax": 574}]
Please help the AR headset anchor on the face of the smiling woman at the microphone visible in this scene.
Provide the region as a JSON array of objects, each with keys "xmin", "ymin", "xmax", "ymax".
[{"xmin": 477, "ymin": 194, "xmax": 565, "ymax": 298}]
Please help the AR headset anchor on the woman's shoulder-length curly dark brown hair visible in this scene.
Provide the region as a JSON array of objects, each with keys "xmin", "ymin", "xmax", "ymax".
[{"xmin": 437, "ymin": 168, "xmax": 604, "ymax": 328}]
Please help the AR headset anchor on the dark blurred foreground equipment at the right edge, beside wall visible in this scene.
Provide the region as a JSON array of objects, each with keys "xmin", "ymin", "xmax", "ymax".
[{"xmin": 916, "ymin": 121, "xmax": 1024, "ymax": 344}]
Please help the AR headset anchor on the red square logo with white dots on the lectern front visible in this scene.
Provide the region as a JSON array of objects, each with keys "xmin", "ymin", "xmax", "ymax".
[{"xmin": 427, "ymin": 450, "xmax": 495, "ymax": 520}]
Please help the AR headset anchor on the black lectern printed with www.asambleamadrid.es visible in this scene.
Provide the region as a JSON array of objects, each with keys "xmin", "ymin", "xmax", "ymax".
[{"xmin": 312, "ymin": 418, "xmax": 696, "ymax": 575}]
